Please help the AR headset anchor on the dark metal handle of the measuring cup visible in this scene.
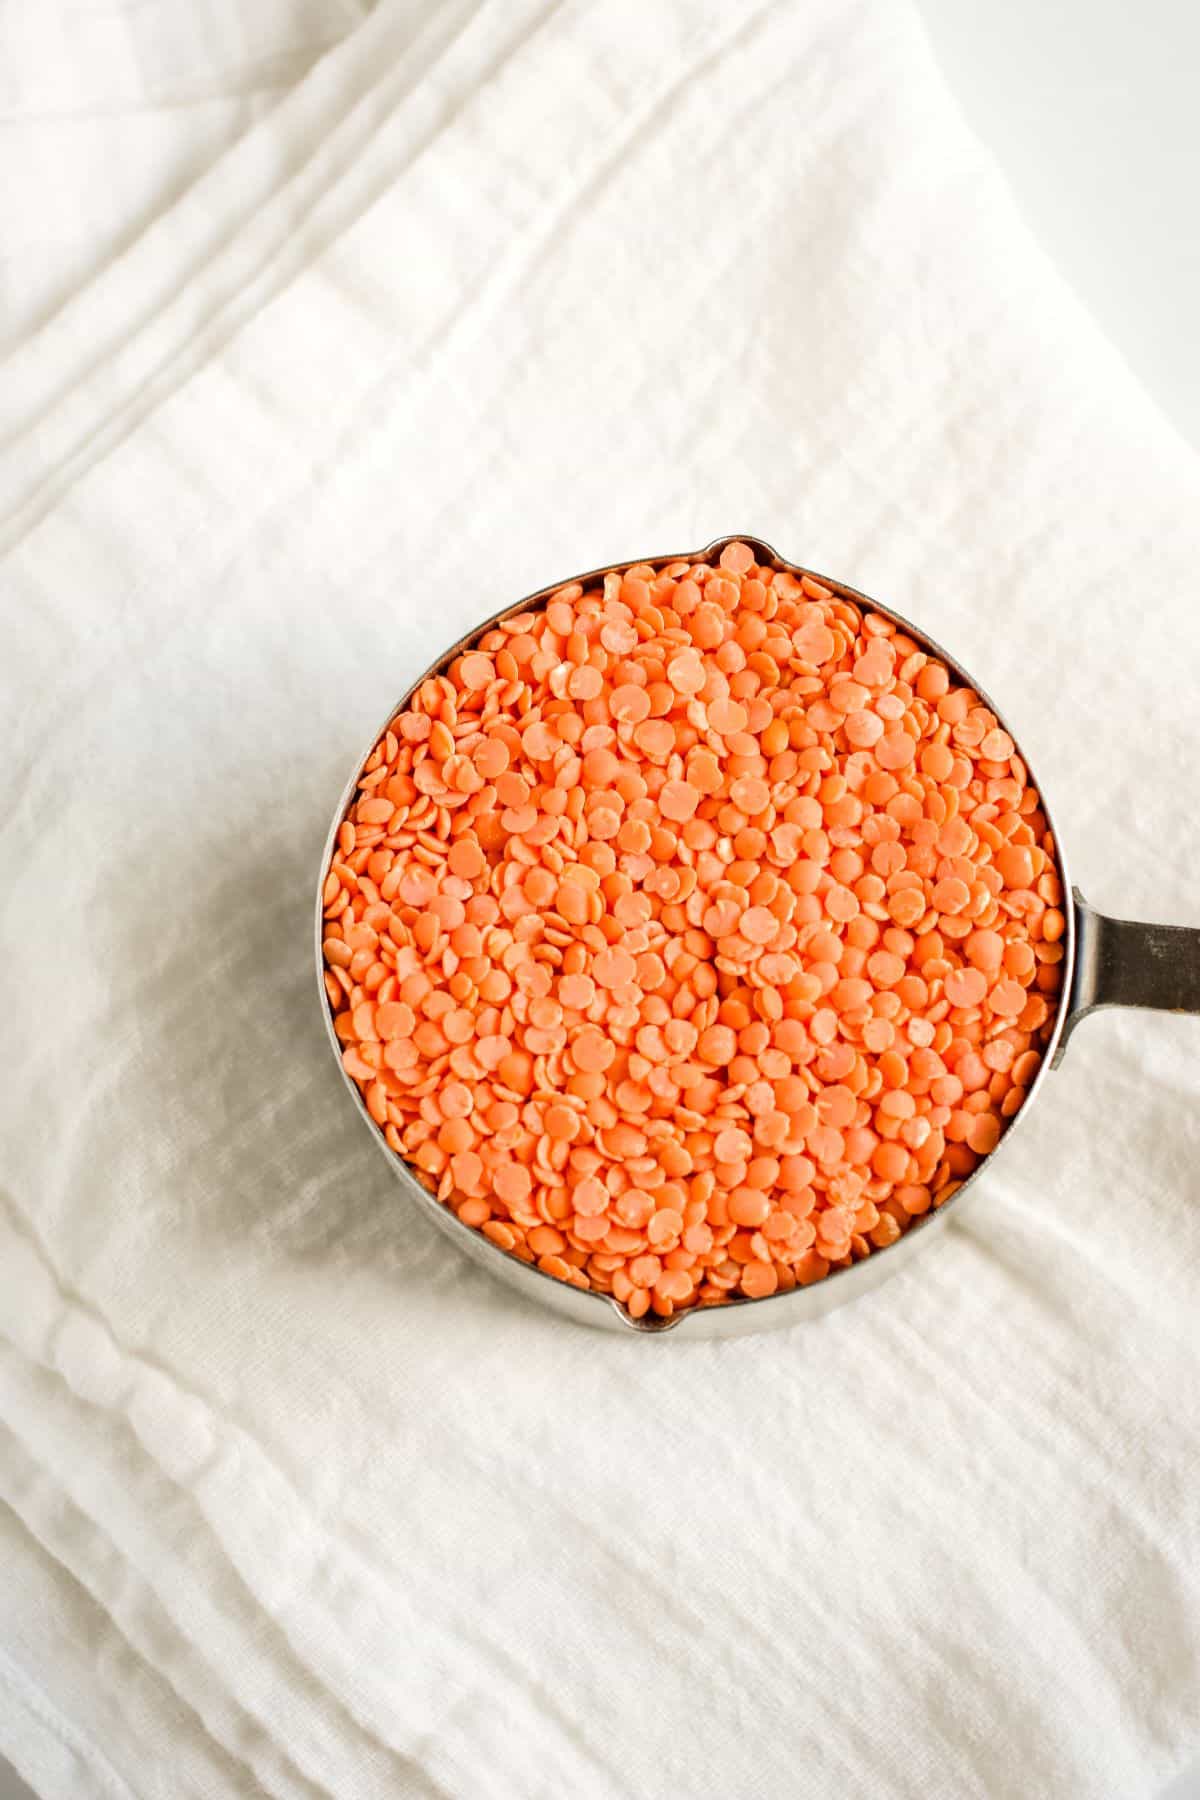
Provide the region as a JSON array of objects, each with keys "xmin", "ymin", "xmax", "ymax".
[{"xmin": 1054, "ymin": 887, "xmax": 1200, "ymax": 1062}]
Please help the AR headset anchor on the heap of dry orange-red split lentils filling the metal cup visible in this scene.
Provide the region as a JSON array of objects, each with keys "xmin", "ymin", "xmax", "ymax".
[{"xmin": 324, "ymin": 544, "xmax": 1065, "ymax": 1318}]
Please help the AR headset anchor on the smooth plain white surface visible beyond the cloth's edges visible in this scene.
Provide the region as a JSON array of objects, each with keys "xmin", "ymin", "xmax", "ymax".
[{"xmin": 0, "ymin": 0, "xmax": 1200, "ymax": 1800}]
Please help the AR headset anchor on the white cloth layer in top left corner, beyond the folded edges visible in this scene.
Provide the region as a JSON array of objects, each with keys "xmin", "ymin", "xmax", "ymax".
[{"xmin": 0, "ymin": 0, "xmax": 363, "ymax": 353}]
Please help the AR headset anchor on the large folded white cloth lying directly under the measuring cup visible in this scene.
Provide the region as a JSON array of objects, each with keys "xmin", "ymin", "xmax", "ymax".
[{"xmin": 0, "ymin": 0, "xmax": 1200, "ymax": 1800}]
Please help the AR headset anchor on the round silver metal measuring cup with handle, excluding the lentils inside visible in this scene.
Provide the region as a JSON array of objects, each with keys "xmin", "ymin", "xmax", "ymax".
[{"xmin": 317, "ymin": 533, "xmax": 1200, "ymax": 1337}]
